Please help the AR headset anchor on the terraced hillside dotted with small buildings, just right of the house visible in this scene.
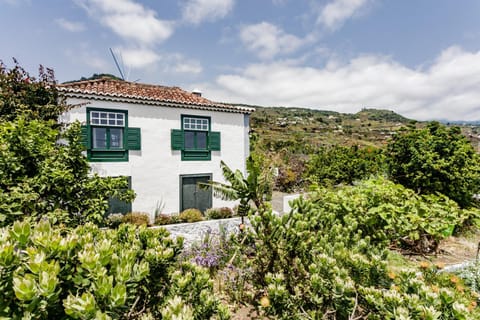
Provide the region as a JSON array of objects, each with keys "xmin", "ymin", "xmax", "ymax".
[{"xmin": 249, "ymin": 106, "xmax": 415, "ymax": 153}]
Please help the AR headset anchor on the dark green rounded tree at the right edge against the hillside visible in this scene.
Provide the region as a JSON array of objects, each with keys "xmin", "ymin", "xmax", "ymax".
[{"xmin": 386, "ymin": 122, "xmax": 480, "ymax": 207}]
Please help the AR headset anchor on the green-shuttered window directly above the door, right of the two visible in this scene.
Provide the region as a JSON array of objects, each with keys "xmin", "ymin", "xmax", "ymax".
[{"xmin": 171, "ymin": 115, "xmax": 221, "ymax": 160}]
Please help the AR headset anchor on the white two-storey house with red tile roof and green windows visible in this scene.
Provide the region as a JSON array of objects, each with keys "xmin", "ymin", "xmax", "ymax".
[{"xmin": 58, "ymin": 78, "xmax": 254, "ymax": 215}]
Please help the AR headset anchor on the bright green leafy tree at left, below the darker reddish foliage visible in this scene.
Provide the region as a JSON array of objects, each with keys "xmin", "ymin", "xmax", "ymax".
[{"xmin": 0, "ymin": 118, "xmax": 134, "ymax": 226}]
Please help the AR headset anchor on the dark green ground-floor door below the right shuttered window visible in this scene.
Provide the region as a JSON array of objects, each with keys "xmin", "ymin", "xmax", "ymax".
[{"xmin": 180, "ymin": 174, "xmax": 212, "ymax": 212}]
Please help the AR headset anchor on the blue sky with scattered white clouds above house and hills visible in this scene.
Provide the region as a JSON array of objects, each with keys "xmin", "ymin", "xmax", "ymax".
[{"xmin": 0, "ymin": 0, "xmax": 480, "ymax": 120}]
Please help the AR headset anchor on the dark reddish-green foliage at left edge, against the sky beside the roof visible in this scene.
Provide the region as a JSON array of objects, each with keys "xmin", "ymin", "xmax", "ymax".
[{"xmin": 0, "ymin": 60, "xmax": 69, "ymax": 121}]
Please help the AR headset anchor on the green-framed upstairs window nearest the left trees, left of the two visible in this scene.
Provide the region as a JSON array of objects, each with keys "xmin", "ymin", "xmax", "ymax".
[{"xmin": 81, "ymin": 108, "xmax": 141, "ymax": 162}]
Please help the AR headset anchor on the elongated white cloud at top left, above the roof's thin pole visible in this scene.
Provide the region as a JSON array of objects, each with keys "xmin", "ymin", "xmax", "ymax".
[{"xmin": 75, "ymin": 0, "xmax": 173, "ymax": 45}]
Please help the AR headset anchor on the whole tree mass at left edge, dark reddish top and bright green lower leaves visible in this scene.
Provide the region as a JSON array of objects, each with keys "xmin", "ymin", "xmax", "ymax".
[{"xmin": 0, "ymin": 60, "xmax": 134, "ymax": 226}]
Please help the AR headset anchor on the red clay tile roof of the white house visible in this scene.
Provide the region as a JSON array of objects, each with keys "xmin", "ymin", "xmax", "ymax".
[{"xmin": 57, "ymin": 78, "xmax": 254, "ymax": 113}]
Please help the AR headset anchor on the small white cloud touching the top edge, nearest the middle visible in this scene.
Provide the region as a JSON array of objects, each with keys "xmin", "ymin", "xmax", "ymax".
[{"xmin": 182, "ymin": 0, "xmax": 234, "ymax": 24}]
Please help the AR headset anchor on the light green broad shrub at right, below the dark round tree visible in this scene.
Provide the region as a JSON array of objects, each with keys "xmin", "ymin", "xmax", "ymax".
[{"xmin": 312, "ymin": 178, "xmax": 478, "ymax": 252}]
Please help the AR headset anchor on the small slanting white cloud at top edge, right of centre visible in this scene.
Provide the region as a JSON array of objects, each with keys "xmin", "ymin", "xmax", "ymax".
[{"xmin": 317, "ymin": 0, "xmax": 369, "ymax": 29}]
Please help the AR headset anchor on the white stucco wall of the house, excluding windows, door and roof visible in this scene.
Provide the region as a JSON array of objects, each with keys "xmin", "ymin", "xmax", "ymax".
[{"xmin": 61, "ymin": 98, "xmax": 249, "ymax": 215}]
